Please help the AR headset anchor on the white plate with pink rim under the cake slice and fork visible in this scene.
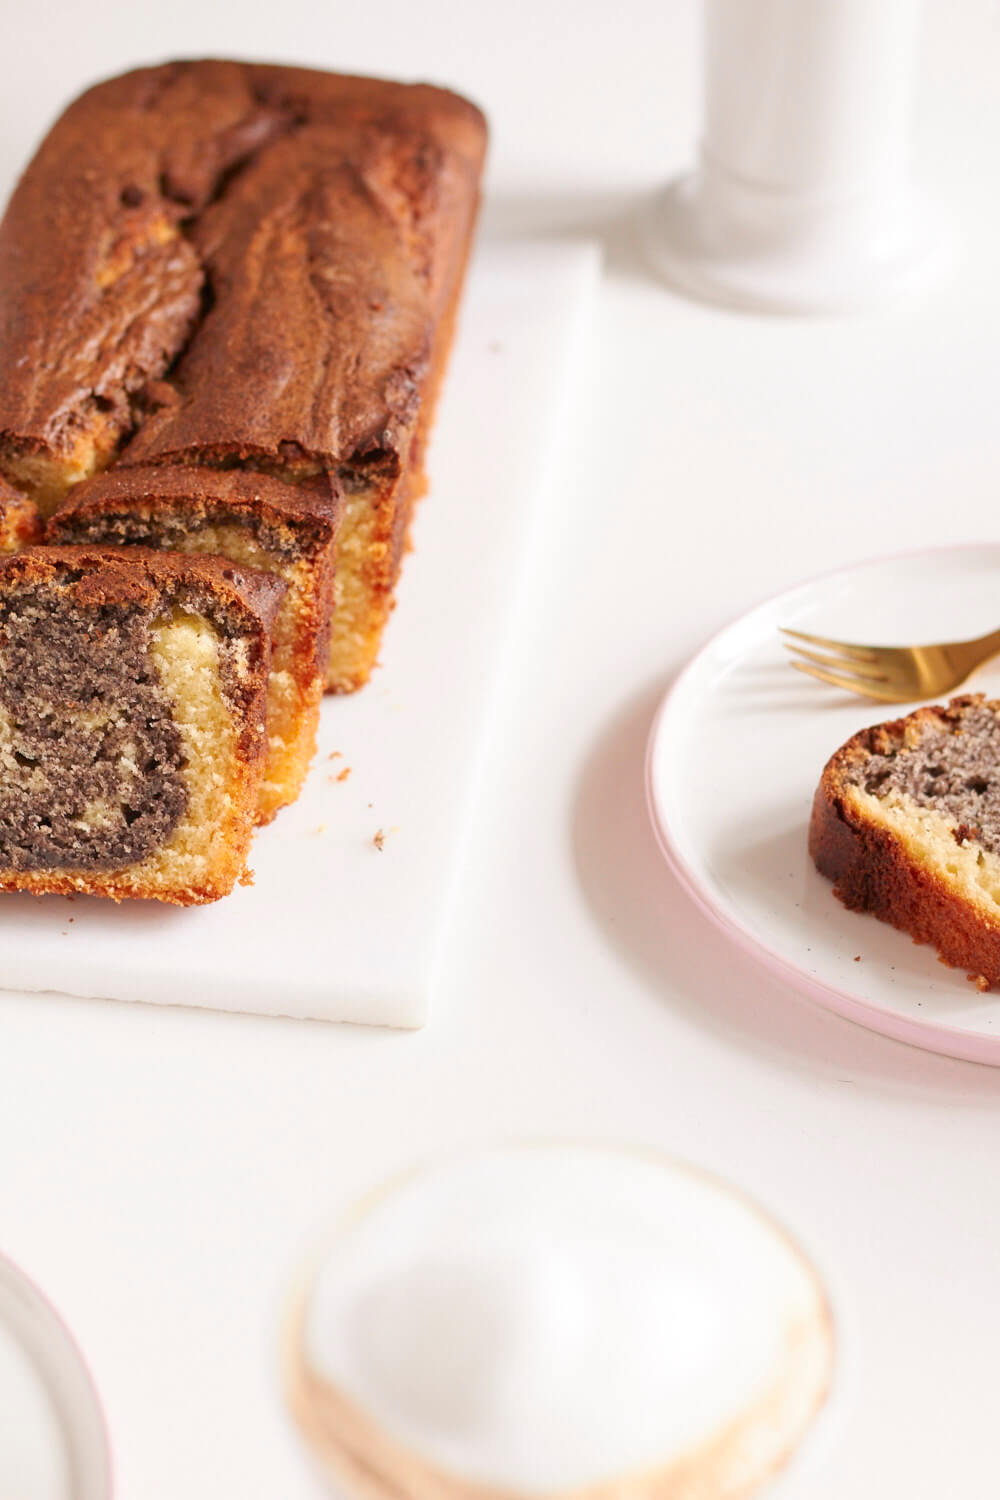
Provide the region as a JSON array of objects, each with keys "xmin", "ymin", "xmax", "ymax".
[{"xmin": 646, "ymin": 543, "xmax": 1000, "ymax": 1065}]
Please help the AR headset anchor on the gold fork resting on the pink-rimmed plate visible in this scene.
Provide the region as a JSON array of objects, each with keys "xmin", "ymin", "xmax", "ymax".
[{"xmin": 780, "ymin": 627, "xmax": 1000, "ymax": 704}]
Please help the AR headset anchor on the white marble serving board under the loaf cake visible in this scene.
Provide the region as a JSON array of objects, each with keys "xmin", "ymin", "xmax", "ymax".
[{"xmin": 0, "ymin": 243, "xmax": 598, "ymax": 1026}]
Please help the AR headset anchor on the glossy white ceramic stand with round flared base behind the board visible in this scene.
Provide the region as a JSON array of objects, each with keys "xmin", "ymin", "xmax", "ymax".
[{"xmin": 646, "ymin": 0, "xmax": 948, "ymax": 314}]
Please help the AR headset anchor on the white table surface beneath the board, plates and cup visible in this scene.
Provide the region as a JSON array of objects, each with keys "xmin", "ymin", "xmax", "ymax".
[{"xmin": 0, "ymin": 0, "xmax": 1000, "ymax": 1500}]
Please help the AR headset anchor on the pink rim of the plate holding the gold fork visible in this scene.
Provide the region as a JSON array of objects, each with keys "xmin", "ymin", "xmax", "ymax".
[{"xmin": 645, "ymin": 540, "xmax": 1000, "ymax": 1068}]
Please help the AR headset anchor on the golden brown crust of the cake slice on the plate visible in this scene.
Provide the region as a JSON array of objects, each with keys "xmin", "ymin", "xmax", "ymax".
[{"xmin": 810, "ymin": 693, "xmax": 1000, "ymax": 989}]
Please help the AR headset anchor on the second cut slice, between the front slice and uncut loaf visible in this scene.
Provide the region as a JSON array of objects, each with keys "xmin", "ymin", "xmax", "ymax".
[{"xmin": 48, "ymin": 467, "xmax": 340, "ymax": 824}]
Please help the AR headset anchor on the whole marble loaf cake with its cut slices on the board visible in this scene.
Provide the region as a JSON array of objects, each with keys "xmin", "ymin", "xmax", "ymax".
[{"xmin": 0, "ymin": 62, "xmax": 486, "ymax": 903}]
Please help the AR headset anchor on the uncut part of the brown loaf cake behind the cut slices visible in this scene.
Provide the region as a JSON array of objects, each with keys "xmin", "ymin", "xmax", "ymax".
[{"xmin": 0, "ymin": 62, "xmax": 486, "ymax": 690}]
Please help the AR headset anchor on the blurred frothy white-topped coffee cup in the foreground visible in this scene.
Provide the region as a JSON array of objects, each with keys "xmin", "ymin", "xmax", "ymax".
[{"xmin": 286, "ymin": 1142, "xmax": 840, "ymax": 1500}]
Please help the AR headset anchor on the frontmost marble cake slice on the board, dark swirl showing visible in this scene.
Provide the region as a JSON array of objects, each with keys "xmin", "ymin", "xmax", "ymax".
[{"xmin": 0, "ymin": 548, "xmax": 285, "ymax": 906}]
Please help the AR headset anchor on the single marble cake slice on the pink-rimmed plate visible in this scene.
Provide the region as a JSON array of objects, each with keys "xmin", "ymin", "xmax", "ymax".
[{"xmin": 810, "ymin": 693, "xmax": 1000, "ymax": 990}]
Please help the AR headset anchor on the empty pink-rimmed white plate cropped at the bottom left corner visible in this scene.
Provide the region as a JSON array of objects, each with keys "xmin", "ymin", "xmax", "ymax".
[{"xmin": 0, "ymin": 1256, "xmax": 111, "ymax": 1500}]
